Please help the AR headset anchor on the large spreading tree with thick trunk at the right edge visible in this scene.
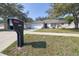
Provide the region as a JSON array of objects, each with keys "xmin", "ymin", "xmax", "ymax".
[{"xmin": 49, "ymin": 3, "xmax": 79, "ymax": 29}]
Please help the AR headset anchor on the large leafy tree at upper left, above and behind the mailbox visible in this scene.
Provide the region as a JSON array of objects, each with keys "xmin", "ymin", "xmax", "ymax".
[{"xmin": 0, "ymin": 3, "xmax": 27, "ymax": 29}]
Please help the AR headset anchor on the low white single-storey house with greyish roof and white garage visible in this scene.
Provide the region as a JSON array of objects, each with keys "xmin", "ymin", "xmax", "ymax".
[{"xmin": 25, "ymin": 19, "xmax": 79, "ymax": 29}]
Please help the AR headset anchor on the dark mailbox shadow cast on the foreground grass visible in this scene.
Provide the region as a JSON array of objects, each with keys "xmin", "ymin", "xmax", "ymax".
[{"xmin": 24, "ymin": 41, "xmax": 46, "ymax": 48}]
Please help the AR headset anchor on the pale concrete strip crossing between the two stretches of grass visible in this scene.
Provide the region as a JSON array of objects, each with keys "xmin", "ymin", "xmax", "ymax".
[{"xmin": 25, "ymin": 31, "xmax": 79, "ymax": 37}]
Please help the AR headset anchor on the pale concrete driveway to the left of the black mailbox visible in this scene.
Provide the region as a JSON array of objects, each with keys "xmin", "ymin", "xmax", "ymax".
[{"xmin": 0, "ymin": 31, "xmax": 17, "ymax": 52}]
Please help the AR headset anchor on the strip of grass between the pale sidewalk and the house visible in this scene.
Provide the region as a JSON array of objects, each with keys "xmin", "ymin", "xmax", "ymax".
[{"xmin": 36, "ymin": 29, "xmax": 79, "ymax": 33}]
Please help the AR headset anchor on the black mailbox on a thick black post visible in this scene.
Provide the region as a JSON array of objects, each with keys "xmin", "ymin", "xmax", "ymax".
[{"xmin": 12, "ymin": 19, "xmax": 24, "ymax": 47}]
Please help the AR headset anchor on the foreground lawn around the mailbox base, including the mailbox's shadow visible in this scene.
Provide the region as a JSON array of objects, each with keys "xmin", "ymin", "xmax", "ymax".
[{"xmin": 2, "ymin": 35, "xmax": 79, "ymax": 56}]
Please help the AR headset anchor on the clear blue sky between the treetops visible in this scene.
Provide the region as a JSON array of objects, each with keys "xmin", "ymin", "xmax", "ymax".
[{"xmin": 22, "ymin": 3, "xmax": 50, "ymax": 19}]
